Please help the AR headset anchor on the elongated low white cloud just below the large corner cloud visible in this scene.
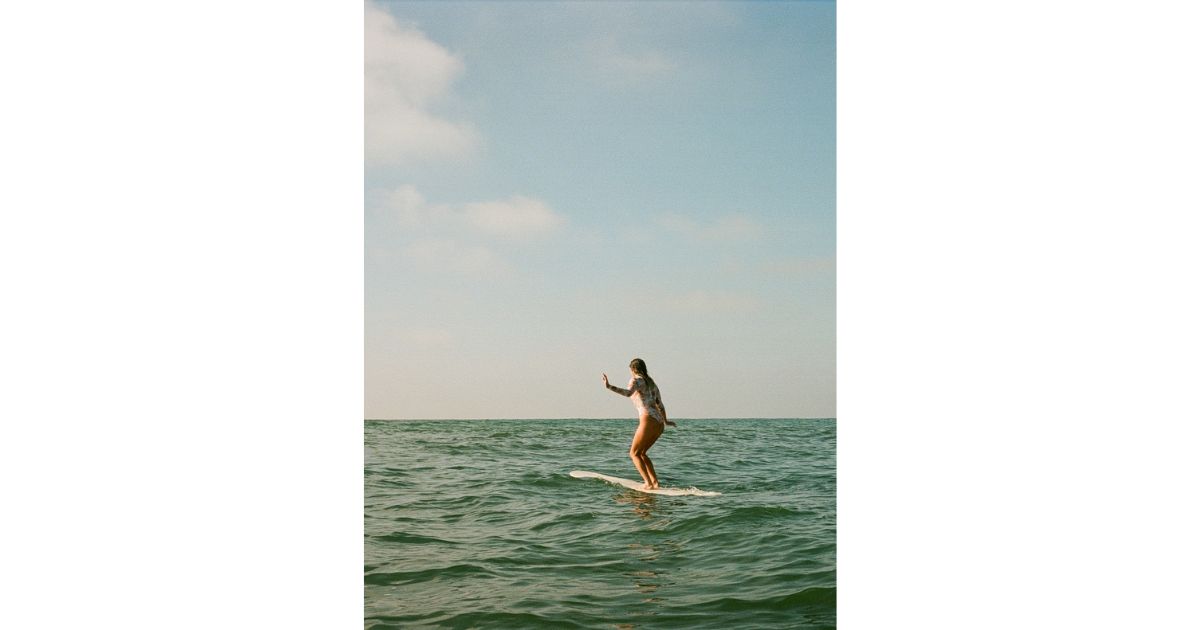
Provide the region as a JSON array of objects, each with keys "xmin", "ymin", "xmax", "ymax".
[{"xmin": 382, "ymin": 186, "xmax": 566, "ymax": 239}]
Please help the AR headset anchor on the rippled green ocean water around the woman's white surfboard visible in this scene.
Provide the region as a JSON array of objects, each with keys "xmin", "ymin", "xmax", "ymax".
[{"xmin": 364, "ymin": 418, "xmax": 838, "ymax": 629}]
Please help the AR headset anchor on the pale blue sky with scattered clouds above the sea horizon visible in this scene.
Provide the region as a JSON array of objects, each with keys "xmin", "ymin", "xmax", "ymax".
[{"xmin": 365, "ymin": 1, "xmax": 836, "ymax": 419}]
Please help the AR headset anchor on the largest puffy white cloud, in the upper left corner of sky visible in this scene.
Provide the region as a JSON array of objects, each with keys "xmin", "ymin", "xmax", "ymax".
[{"xmin": 364, "ymin": 2, "xmax": 478, "ymax": 166}]
